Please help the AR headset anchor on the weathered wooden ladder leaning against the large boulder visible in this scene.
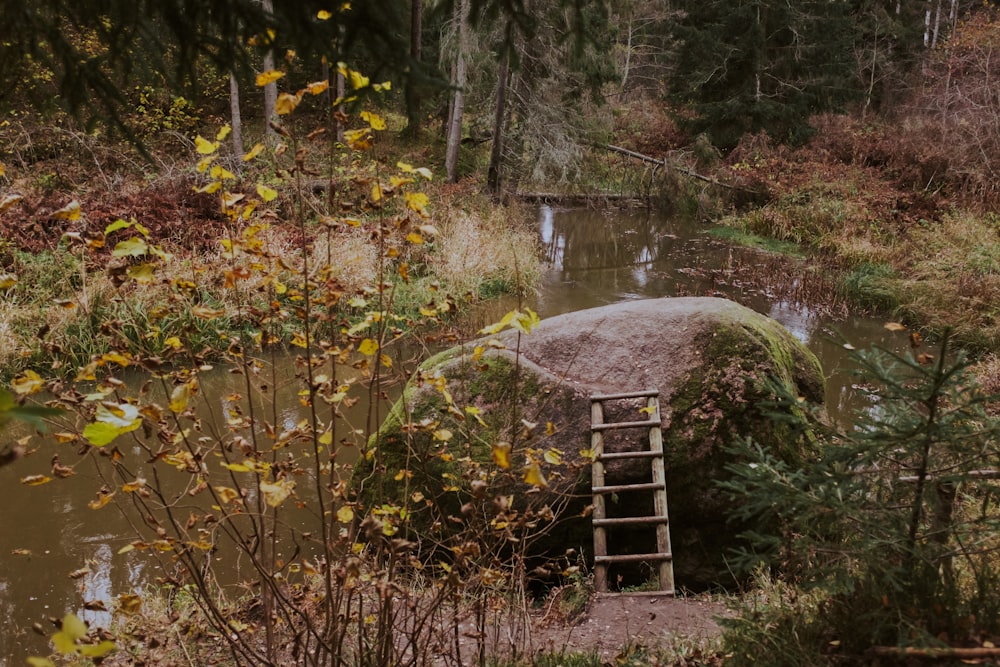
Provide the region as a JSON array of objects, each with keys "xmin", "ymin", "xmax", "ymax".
[{"xmin": 590, "ymin": 389, "xmax": 674, "ymax": 595}]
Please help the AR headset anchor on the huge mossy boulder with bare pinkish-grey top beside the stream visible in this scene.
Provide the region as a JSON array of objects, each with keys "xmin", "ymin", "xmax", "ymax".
[{"xmin": 354, "ymin": 297, "xmax": 824, "ymax": 589}]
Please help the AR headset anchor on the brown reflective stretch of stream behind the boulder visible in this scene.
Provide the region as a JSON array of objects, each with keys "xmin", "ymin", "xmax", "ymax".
[{"xmin": 536, "ymin": 206, "xmax": 906, "ymax": 420}]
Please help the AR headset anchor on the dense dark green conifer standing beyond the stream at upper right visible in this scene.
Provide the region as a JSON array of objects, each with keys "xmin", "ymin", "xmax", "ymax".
[{"xmin": 671, "ymin": 0, "xmax": 854, "ymax": 148}]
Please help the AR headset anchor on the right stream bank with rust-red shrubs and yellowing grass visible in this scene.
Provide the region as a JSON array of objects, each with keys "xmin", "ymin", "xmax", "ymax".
[{"xmin": 720, "ymin": 117, "xmax": 1000, "ymax": 354}]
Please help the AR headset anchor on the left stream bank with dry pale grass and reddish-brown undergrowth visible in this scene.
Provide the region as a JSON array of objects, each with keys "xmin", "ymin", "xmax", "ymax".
[{"xmin": 0, "ymin": 120, "xmax": 540, "ymax": 379}]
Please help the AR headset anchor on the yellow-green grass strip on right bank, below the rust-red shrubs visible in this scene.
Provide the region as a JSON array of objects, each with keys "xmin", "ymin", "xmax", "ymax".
[{"xmin": 720, "ymin": 170, "xmax": 1000, "ymax": 352}]
